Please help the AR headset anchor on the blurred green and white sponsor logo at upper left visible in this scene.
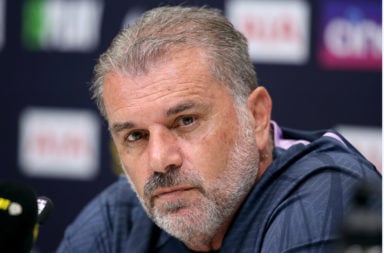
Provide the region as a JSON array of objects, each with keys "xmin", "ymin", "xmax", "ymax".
[{"xmin": 22, "ymin": 0, "xmax": 103, "ymax": 52}]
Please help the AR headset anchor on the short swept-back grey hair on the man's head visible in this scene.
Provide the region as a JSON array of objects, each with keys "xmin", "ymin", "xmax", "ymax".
[{"xmin": 91, "ymin": 6, "xmax": 257, "ymax": 117}]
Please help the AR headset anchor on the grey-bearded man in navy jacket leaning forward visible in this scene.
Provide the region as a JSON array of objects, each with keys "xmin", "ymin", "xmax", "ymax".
[{"xmin": 59, "ymin": 7, "xmax": 381, "ymax": 253}]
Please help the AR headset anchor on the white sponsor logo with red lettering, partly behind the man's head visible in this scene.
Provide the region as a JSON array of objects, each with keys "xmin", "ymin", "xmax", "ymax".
[{"xmin": 226, "ymin": 0, "xmax": 310, "ymax": 64}]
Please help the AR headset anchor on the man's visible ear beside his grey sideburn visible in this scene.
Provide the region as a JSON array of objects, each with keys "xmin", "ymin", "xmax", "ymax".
[{"xmin": 247, "ymin": 86, "xmax": 272, "ymax": 153}]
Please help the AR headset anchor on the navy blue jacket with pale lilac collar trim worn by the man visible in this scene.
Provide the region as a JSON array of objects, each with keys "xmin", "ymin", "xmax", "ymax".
[{"xmin": 58, "ymin": 125, "xmax": 381, "ymax": 253}]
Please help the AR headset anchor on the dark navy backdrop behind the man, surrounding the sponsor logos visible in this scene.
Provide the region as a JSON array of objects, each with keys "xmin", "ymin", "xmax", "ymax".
[{"xmin": 0, "ymin": 0, "xmax": 382, "ymax": 252}]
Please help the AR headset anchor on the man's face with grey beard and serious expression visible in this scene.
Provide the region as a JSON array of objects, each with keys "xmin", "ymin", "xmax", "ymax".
[{"xmin": 104, "ymin": 47, "xmax": 259, "ymax": 245}]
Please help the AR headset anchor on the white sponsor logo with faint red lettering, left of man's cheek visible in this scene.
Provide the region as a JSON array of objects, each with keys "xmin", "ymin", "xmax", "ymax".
[{"xmin": 18, "ymin": 108, "xmax": 100, "ymax": 180}]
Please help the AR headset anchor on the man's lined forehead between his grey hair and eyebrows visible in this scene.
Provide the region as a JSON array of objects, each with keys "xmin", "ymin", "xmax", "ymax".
[{"xmin": 103, "ymin": 49, "xmax": 231, "ymax": 117}]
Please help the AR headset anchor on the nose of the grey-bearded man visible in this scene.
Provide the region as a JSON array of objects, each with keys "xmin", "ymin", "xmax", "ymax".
[{"xmin": 147, "ymin": 126, "xmax": 182, "ymax": 173}]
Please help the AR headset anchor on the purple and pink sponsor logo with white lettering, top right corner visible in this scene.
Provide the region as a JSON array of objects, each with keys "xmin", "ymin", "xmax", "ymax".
[{"xmin": 318, "ymin": 0, "xmax": 382, "ymax": 70}]
